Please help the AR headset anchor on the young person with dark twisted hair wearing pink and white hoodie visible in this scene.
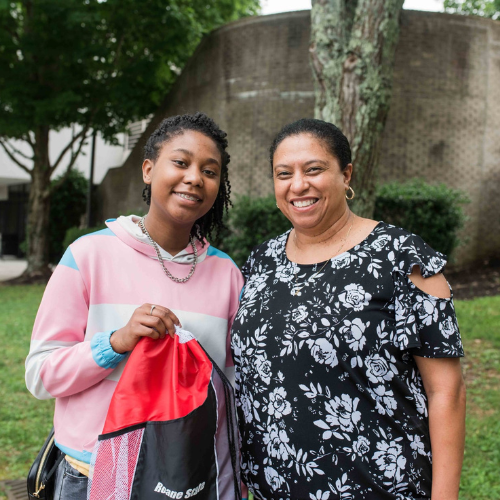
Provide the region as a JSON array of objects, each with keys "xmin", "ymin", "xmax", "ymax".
[{"xmin": 26, "ymin": 113, "xmax": 243, "ymax": 500}]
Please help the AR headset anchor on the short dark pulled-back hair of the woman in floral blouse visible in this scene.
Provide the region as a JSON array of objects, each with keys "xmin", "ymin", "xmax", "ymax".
[{"xmin": 269, "ymin": 118, "xmax": 351, "ymax": 171}]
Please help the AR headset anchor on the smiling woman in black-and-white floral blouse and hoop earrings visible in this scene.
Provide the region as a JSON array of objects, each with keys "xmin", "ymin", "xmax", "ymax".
[{"xmin": 232, "ymin": 119, "xmax": 465, "ymax": 500}]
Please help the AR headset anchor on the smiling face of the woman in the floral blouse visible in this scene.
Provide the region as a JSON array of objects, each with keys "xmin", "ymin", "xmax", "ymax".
[{"xmin": 273, "ymin": 134, "xmax": 352, "ymax": 234}]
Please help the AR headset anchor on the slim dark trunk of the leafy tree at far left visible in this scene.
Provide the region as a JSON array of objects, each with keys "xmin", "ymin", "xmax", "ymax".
[{"xmin": 21, "ymin": 127, "xmax": 51, "ymax": 281}]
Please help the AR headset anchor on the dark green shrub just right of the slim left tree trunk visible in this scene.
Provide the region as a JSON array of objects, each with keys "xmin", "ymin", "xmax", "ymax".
[{"xmin": 50, "ymin": 170, "xmax": 88, "ymax": 263}]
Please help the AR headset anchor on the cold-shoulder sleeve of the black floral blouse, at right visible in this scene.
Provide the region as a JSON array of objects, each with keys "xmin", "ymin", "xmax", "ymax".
[{"xmin": 393, "ymin": 235, "xmax": 464, "ymax": 358}]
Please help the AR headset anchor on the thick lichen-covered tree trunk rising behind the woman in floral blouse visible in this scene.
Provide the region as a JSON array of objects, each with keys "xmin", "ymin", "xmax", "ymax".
[{"xmin": 310, "ymin": 0, "xmax": 404, "ymax": 217}]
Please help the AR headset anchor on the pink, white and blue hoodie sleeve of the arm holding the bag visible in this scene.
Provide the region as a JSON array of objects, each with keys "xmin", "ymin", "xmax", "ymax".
[{"xmin": 26, "ymin": 244, "xmax": 125, "ymax": 399}]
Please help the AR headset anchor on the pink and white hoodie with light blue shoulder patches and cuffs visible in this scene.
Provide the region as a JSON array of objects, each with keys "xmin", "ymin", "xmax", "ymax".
[{"xmin": 26, "ymin": 216, "xmax": 243, "ymax": 463}]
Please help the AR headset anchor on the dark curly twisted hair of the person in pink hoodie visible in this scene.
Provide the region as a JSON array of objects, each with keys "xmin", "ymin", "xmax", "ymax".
[{"xmin": 142, "ymin": 112, "xmax": 232, "ymax": 242}]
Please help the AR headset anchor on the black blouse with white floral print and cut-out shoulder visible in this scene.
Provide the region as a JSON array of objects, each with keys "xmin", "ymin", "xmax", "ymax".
[{"xmin": 232, "ymin": 222, "xmax": 463, "ymax": 500}]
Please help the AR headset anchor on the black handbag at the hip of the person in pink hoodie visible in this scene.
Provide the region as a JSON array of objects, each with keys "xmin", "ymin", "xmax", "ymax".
[{"xmin": 27, "ymin": 427, "xmax": 64, "ymax": 500}]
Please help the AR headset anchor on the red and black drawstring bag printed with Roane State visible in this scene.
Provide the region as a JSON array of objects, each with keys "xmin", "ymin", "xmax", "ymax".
[{"xmin": 88, "ymin": 329, "xmax": 241, "ymax": 500}]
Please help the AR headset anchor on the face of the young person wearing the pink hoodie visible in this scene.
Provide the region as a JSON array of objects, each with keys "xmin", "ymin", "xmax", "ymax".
[{"xmin": 142, "ymin": 130, "xmax": 221, "ymax": 226}]
